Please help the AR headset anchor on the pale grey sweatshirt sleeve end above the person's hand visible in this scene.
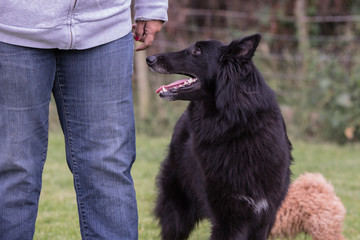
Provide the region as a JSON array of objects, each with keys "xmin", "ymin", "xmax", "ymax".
[{"xmin": 135, "ymin": 0, "xmax": 168, "ymax": 22}]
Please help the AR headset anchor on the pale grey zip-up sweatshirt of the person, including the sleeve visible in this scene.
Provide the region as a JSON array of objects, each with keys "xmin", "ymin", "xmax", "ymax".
[{"xmin": 0, "ymin": 0, "xmax": 168, "ymax": 49}]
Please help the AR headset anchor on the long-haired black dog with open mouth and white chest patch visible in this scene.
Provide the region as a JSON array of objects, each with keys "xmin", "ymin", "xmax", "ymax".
[{"xmin": 146, "ymin": 34, "xmax": 292, "ymax": 240}]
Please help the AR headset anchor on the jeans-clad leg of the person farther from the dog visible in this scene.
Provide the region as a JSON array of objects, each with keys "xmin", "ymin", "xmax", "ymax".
[{"xmin": 0, "ymin": 42, "xmax": 55, "ymax": 240}]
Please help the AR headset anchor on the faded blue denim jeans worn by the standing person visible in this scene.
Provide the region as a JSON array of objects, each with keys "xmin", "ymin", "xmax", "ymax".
[{"xmin": 0, "ymin": 33, "xmax": 138, "ymax": 240}]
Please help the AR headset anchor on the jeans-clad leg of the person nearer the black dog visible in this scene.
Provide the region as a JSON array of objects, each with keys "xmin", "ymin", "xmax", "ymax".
[{"xmin": 53, "ymin": 34, "xmax": 138, "ymax": 240}]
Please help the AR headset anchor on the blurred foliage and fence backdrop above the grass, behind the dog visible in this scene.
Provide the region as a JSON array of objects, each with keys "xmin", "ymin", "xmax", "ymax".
[{"xmin": 134, "ymin": 0, "xmax": 360, "ymax": 143}]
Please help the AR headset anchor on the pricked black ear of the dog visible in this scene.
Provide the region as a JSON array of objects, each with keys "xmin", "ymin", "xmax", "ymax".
[{"xmin": 224, "ymin": 34, "xmax": 261, "ymax": 59}]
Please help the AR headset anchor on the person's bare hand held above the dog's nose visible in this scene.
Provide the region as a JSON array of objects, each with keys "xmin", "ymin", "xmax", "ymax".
[{"xmin": 132, "ymin": 20, "xmax": 163, "ymax": 51}]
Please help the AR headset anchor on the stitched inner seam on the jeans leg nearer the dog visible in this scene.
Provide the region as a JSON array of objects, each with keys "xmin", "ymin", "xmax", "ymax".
[{"xmin": 56, "ymin": 59, "xmax": 89, "ymax": 240}]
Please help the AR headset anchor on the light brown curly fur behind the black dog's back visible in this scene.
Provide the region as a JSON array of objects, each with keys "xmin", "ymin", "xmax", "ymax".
[{"xmin": 269, "ymin": 173, "xmax": 346, "ymax": 240}]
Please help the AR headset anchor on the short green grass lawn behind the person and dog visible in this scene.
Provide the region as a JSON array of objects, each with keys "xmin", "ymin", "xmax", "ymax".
[{"xmin": 34, "ymin": 133, "xmax": 360, "ymax": 240}]
